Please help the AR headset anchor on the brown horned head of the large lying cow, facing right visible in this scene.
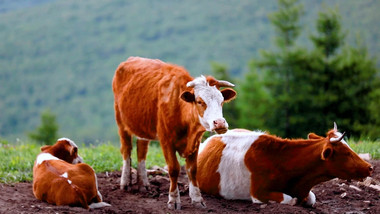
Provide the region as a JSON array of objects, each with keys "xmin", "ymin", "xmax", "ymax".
[{"xmin": 309, "ymin": 123, "xmax": 373, "ymax": 180}]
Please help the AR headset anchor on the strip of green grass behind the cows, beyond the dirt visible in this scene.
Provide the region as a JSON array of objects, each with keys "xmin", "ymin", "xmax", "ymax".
[{"xmin": 0, "ymin": 140, "xmax": 380, "ymax": 183}]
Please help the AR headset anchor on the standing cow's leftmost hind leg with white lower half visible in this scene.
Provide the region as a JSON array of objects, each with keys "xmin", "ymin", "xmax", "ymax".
[{"xmin": 119, "ymin": 130, "xmax": 132, "ymax": 190}]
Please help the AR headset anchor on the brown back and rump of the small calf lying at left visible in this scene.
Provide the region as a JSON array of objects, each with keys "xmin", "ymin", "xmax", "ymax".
[{"xmin": 33, "ymin": 160, "xmax": 97, "ymax": 208}]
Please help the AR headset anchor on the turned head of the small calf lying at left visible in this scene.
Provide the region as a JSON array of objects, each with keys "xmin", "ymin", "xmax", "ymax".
[{"xmin": 41, "ymin": 138, "xmax": 83, "ymax": 164}]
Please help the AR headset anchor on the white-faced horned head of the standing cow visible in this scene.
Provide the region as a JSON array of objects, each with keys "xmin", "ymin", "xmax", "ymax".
[{"xmin": 181, "ymin": 76, "xmax": 236, "ymax": 134}]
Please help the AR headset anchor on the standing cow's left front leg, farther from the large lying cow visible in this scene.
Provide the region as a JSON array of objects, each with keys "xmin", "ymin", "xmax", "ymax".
[{"xmin": 161, "ymin": 145, "xmax": 181, "ymax": 210}]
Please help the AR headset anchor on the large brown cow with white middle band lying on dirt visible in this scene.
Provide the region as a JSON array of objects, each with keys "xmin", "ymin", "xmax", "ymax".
[{"xmin": 198, "ymin": 126, "xmax": 372, "ymax": 206}]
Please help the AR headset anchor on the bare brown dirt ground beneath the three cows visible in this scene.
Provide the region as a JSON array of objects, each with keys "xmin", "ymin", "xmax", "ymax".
[{"xmin": 0, "ymin": 160, "xmax": 380, "ymax": 214}]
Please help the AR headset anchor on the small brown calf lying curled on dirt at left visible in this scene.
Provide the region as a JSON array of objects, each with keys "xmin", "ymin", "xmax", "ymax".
[{"xmin": 33, "ymin": 138, "xmax": 110, "ymax": 209}]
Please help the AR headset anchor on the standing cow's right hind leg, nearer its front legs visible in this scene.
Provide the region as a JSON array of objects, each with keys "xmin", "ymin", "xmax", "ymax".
[{"xmin": 136, "ymin": 139, "xmax": 150, "ymax": 192}]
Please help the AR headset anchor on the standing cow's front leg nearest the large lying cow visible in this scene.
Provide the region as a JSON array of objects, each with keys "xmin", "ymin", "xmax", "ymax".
[{"xmin": 186, "ymin": 152, "xmax": 206, "ymax": 208}]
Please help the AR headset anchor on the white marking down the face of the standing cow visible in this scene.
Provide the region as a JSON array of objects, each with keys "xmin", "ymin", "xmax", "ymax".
[{"xmin": 187, "ymin": 75, "xmax": 228, "ymax": 131}]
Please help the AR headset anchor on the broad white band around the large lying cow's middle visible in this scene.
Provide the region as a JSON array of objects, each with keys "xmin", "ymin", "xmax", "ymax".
[{"xmin": 217, "ymin": 130, "xmax": 264, "ymax": 200}]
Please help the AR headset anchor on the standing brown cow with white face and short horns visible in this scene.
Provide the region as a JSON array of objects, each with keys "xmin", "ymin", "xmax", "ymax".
[{"xmin": 112, "ymin": 57, "xmax": 236, "ymax": 209}]
